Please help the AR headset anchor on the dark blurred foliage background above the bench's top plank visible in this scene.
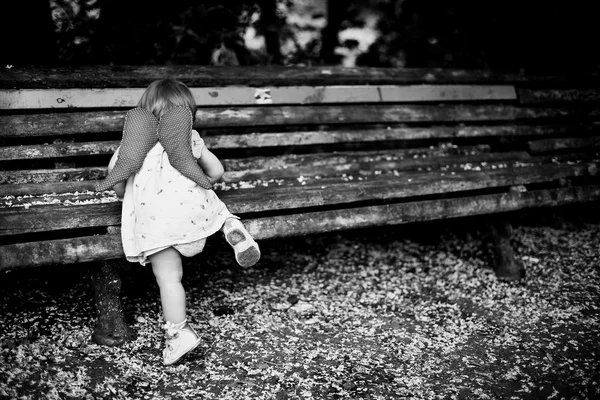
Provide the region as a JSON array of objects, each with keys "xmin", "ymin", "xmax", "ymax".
[{"xmin": 0, "ymin": 0, "xmax": 600, "ymax": 72}]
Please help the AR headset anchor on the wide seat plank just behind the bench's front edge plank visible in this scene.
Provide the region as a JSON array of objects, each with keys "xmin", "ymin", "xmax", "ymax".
[{"xmin": 0, "ymin": 163, "xmax": 598, "ymax": 236}]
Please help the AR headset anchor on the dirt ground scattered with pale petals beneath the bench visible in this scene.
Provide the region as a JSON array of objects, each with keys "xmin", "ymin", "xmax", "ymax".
[{"xmin": 0, "ymin": 204, "xmax": 600, "ymax": 399}]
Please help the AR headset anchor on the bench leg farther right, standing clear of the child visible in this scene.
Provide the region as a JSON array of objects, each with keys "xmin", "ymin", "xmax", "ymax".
[{"xmin": 490, "ymin": 220, "xmax": 525, "ymax": 281}]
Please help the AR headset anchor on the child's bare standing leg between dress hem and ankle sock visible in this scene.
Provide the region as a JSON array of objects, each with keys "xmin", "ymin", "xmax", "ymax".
[{"xmin": 149, "ymin": 247, "xmax": 186, "ymax": 324}]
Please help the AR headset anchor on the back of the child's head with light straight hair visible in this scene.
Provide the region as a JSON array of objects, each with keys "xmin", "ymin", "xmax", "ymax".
[{"xmin": 138, "ymin": 79, "xmax": 196, "ymax": 120}]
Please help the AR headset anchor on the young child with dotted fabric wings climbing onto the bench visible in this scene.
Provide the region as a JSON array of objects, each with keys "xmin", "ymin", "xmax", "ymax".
[{"xmin": 98, "ymin": 79, "xmax": 260, "ymax": 365}]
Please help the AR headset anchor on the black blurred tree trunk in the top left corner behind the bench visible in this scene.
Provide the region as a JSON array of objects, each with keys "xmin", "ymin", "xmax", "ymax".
[{"xmin": 0, "ymin": 0, "xmax": 57, "ymax": 68}]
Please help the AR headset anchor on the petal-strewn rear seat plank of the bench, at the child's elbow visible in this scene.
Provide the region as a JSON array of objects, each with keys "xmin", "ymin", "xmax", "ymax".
[{"xmin": 0, "ymin": 147, "xmax": 598, "ymax": 198}]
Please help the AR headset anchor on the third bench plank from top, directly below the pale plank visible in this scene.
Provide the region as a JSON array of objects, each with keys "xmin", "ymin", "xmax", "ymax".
[{"xmin": 0, "ymin": 104, "xmax": 600, "ymax": 138}]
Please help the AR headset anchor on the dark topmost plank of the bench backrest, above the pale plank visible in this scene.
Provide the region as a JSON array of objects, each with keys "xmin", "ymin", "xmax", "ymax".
[{"xmin": 0, "ymin": 65, "xmax": 600, "ymax": 89}]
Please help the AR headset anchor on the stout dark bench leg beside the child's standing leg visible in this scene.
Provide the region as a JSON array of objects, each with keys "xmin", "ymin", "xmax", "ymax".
[{"xmin": 92, "ymin": 261, "xmax": 135, "ymax": 346}]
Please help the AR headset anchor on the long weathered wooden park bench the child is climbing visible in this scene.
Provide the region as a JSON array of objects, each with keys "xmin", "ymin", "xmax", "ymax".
[{"xmin": 0, "ymin": 66, "xmax": 600, "ymax": 344}]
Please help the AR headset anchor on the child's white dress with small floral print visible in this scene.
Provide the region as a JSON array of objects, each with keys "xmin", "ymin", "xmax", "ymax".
[{"xmin": 121, "ymin": 131, "xmax": 237, "ymax": 265}]
